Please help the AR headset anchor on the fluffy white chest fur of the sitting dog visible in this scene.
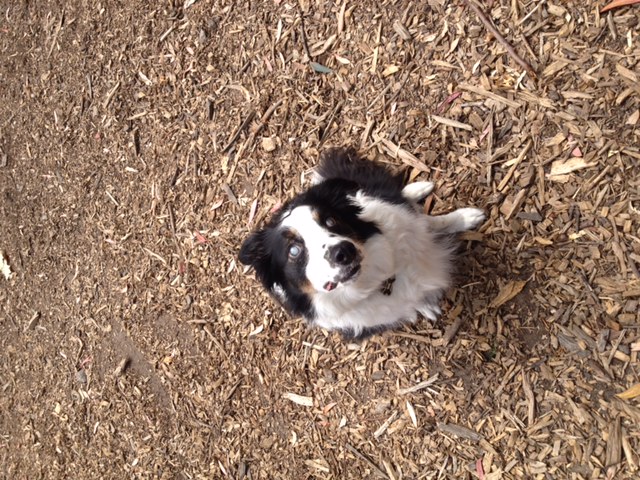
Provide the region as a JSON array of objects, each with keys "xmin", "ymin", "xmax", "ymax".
[{"xmin": 314, "ymin": 193, "xmax": 455, "ymax": 336}]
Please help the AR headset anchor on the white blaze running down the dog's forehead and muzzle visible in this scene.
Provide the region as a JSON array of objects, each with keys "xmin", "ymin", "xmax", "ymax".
[{"xmin": 282, "ymin": 206, "xmax": 344, "ymax": 290}]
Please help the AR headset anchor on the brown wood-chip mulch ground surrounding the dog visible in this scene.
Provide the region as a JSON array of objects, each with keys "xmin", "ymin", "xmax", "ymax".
[{"xmin": 0, "ymin": 0, "xmax": 640, "ymax": 479}]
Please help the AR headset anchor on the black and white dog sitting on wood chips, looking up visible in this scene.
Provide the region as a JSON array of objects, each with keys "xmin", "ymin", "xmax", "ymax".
[{"xmin": 240, "ymin": 149, "xmax": 484, "ymax": 339}]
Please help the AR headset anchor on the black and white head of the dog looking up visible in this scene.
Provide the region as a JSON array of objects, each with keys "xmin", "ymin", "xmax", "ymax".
[{"xmin": 239, "ymin": 179, "xmax": 379, "ymax": 310}]
